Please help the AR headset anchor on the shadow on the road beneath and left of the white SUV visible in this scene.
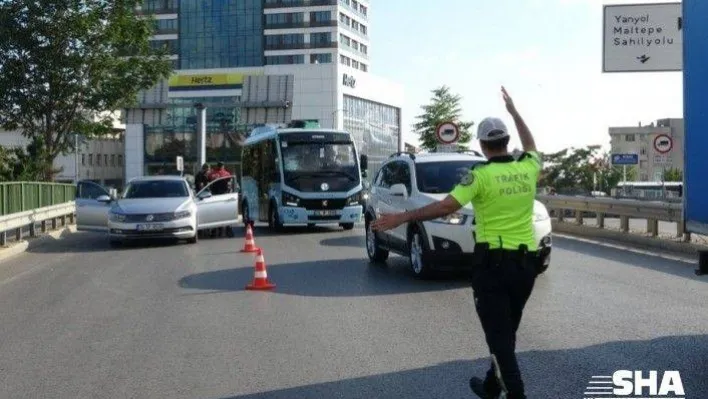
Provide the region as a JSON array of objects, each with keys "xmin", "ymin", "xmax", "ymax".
[{"xmin": 178, "ymin": 258, "xmax": 469, "ymax": 297}]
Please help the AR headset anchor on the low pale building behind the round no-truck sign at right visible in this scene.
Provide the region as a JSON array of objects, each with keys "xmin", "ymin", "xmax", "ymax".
[{"xmin": 609, "ymin": 118, "xmax": 684, "ymax": 181}]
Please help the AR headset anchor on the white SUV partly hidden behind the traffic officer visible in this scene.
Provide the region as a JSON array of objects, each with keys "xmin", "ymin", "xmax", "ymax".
[{"xmin": 365, "ymin": 152, "xmax": 551, "ymax": 277}]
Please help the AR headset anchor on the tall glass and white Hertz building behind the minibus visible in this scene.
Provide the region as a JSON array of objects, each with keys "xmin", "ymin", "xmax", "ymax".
[{"xmin": 124, "ymin": 0, "xmax": 403, "ymax": 184}]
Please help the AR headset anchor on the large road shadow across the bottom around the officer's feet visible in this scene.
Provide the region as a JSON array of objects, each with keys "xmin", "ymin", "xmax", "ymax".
[{"xmin": 212, "ymin": 335, "xmax": 708, "ymax": 399}]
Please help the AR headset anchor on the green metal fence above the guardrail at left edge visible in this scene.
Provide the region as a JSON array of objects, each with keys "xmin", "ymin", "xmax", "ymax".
[{"xmin": 0, "ymin": 182, "xmax": 76, "ymax": 216}]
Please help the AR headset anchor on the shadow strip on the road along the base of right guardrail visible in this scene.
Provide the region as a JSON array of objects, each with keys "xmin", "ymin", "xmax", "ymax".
[{"xmin": 551, "ymin": 236, "xmax": 708, "ymax": 282}]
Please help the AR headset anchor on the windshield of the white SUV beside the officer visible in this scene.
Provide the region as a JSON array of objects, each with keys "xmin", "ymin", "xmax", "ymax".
[{"xmin": 415, "ymin": 160, "xmax": 482, "ymax": 194}]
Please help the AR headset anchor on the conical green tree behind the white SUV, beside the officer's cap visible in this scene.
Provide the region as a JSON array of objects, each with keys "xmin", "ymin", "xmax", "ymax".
[{"xmin": 413, "ymin": 86, "xmax": 474, "ymax": 151}]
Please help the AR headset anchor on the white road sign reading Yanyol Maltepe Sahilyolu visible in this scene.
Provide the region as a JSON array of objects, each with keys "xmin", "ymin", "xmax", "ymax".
[{"xmin": 602, "ymin": 2, "xmax": 685, "ymax": 72}]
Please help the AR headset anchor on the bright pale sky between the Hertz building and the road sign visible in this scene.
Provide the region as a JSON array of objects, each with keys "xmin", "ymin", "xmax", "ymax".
[{"xmin": 370, "ymin": 0, "xmax": 683, "ymax": 152}]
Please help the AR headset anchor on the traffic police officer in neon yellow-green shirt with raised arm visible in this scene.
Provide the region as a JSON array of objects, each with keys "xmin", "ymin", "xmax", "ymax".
[{"xmin": 372, "ymin": 87, "xmax": 542, "ymax": 399}]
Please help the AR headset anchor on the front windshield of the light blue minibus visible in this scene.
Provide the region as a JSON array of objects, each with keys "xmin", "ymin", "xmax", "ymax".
[{"xmin": 280, "ymin": 142, "xmax": 360, "ymax": 191}]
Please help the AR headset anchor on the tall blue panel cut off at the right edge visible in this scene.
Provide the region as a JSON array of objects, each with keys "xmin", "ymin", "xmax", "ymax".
[{"xmin": 681, "ymin": 0, "xmax": 708, "ymax": 234}]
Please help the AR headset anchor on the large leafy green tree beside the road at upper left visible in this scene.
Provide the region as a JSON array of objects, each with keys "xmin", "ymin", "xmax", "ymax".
[{"xmin": 0, "ymin": 0, "xmax": 172, "ymax": 180}]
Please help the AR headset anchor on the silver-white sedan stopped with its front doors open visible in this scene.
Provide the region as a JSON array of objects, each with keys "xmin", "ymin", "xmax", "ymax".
[{"xmin": 76, "ymin": 176, "xmax": 238, "ymax": 245}]
